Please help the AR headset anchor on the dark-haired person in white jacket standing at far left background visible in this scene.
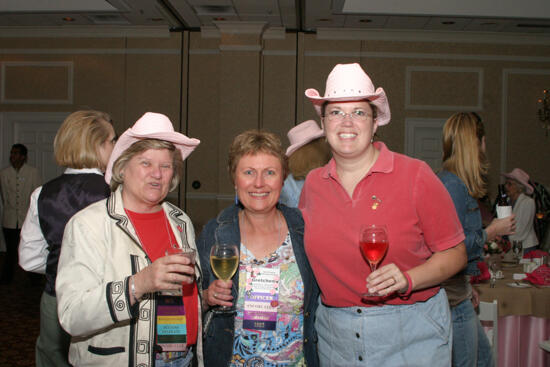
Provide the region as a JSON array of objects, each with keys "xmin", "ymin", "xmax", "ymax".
[{"xmin": 0, "ymin": 144, "xmax": 42, "ymax": 284}]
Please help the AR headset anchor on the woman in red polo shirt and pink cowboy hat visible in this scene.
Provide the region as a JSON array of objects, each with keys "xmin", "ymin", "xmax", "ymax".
[{"xmin": 299, "ymin": 64, "xmax": 466, "ymax": 366}]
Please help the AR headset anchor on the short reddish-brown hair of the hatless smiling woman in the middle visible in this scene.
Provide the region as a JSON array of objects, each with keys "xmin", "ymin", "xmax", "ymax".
[{"xmin": 227, "ymin": 129, "xmax": 288, "ymax": 184}]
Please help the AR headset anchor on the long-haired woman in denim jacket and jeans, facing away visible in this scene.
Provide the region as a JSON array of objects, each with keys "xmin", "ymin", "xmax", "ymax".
[{"xmin": 438, "ymin": 112, "xmax": 515, "ymax": 367}]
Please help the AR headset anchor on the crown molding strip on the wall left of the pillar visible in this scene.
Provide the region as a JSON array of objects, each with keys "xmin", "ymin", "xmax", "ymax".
[{"xmin": 0, "ymin": 25, "xmax": 170, "ymax": 38}]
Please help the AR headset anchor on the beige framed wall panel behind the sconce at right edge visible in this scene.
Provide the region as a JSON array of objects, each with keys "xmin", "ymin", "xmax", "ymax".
[{"xmin": 505, "ymin": 73, "xmax": 550, "ymax": 185}]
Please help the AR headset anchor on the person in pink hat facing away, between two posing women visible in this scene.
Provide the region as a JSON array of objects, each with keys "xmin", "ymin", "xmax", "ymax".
[{"xmin": 279, "ymin": 120, "xmax": 330, "ymax": 208}]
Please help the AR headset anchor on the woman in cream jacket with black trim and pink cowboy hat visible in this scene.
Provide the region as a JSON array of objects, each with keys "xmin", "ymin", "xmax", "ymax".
[{"xmin": 56, "ymin": 112, "xmax": 202, "ymax": 367}]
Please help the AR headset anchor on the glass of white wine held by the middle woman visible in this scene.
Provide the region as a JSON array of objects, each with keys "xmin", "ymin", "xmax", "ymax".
[{"xmin": 210, "ymin": 243, "xmax": 239, "ymax": 313}]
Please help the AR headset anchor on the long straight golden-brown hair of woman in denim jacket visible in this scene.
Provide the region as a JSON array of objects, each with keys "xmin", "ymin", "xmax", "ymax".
[{"xmin": 443, "ymin": 112, "xmax": 489, "ymax": 198}]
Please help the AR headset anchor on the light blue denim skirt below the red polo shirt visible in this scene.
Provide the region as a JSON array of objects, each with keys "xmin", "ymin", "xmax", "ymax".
[{"xmin": 315, "ymin": 289, "xmax": 452, "ymax": 367}]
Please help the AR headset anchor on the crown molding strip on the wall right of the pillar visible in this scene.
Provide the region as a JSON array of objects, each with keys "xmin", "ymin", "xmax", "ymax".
[{"xmin": 317, "ymin": 28, "xmax": 550, "ymax": 45}]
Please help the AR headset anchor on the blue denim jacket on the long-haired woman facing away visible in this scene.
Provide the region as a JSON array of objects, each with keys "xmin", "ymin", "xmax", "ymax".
[{"xmin": 438, "ymin": 171, "xmax": 487, "ymax": 275}]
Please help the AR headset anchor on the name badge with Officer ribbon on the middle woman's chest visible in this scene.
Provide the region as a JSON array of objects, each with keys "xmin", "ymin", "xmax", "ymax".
[{"xmin": 243, "ymin": 266, "xmax": 280, "ymax": 330}]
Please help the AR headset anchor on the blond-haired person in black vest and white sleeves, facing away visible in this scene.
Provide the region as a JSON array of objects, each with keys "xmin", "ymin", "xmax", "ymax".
[{"xmin": 19, "ymin": 110, "xmax": 115, "ymax": 367}]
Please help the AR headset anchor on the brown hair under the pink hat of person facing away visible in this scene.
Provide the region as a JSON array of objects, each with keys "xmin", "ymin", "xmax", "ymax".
[{"xmin": 288, "ymin": 137, "xmax": 332, "ymax": 180}]
